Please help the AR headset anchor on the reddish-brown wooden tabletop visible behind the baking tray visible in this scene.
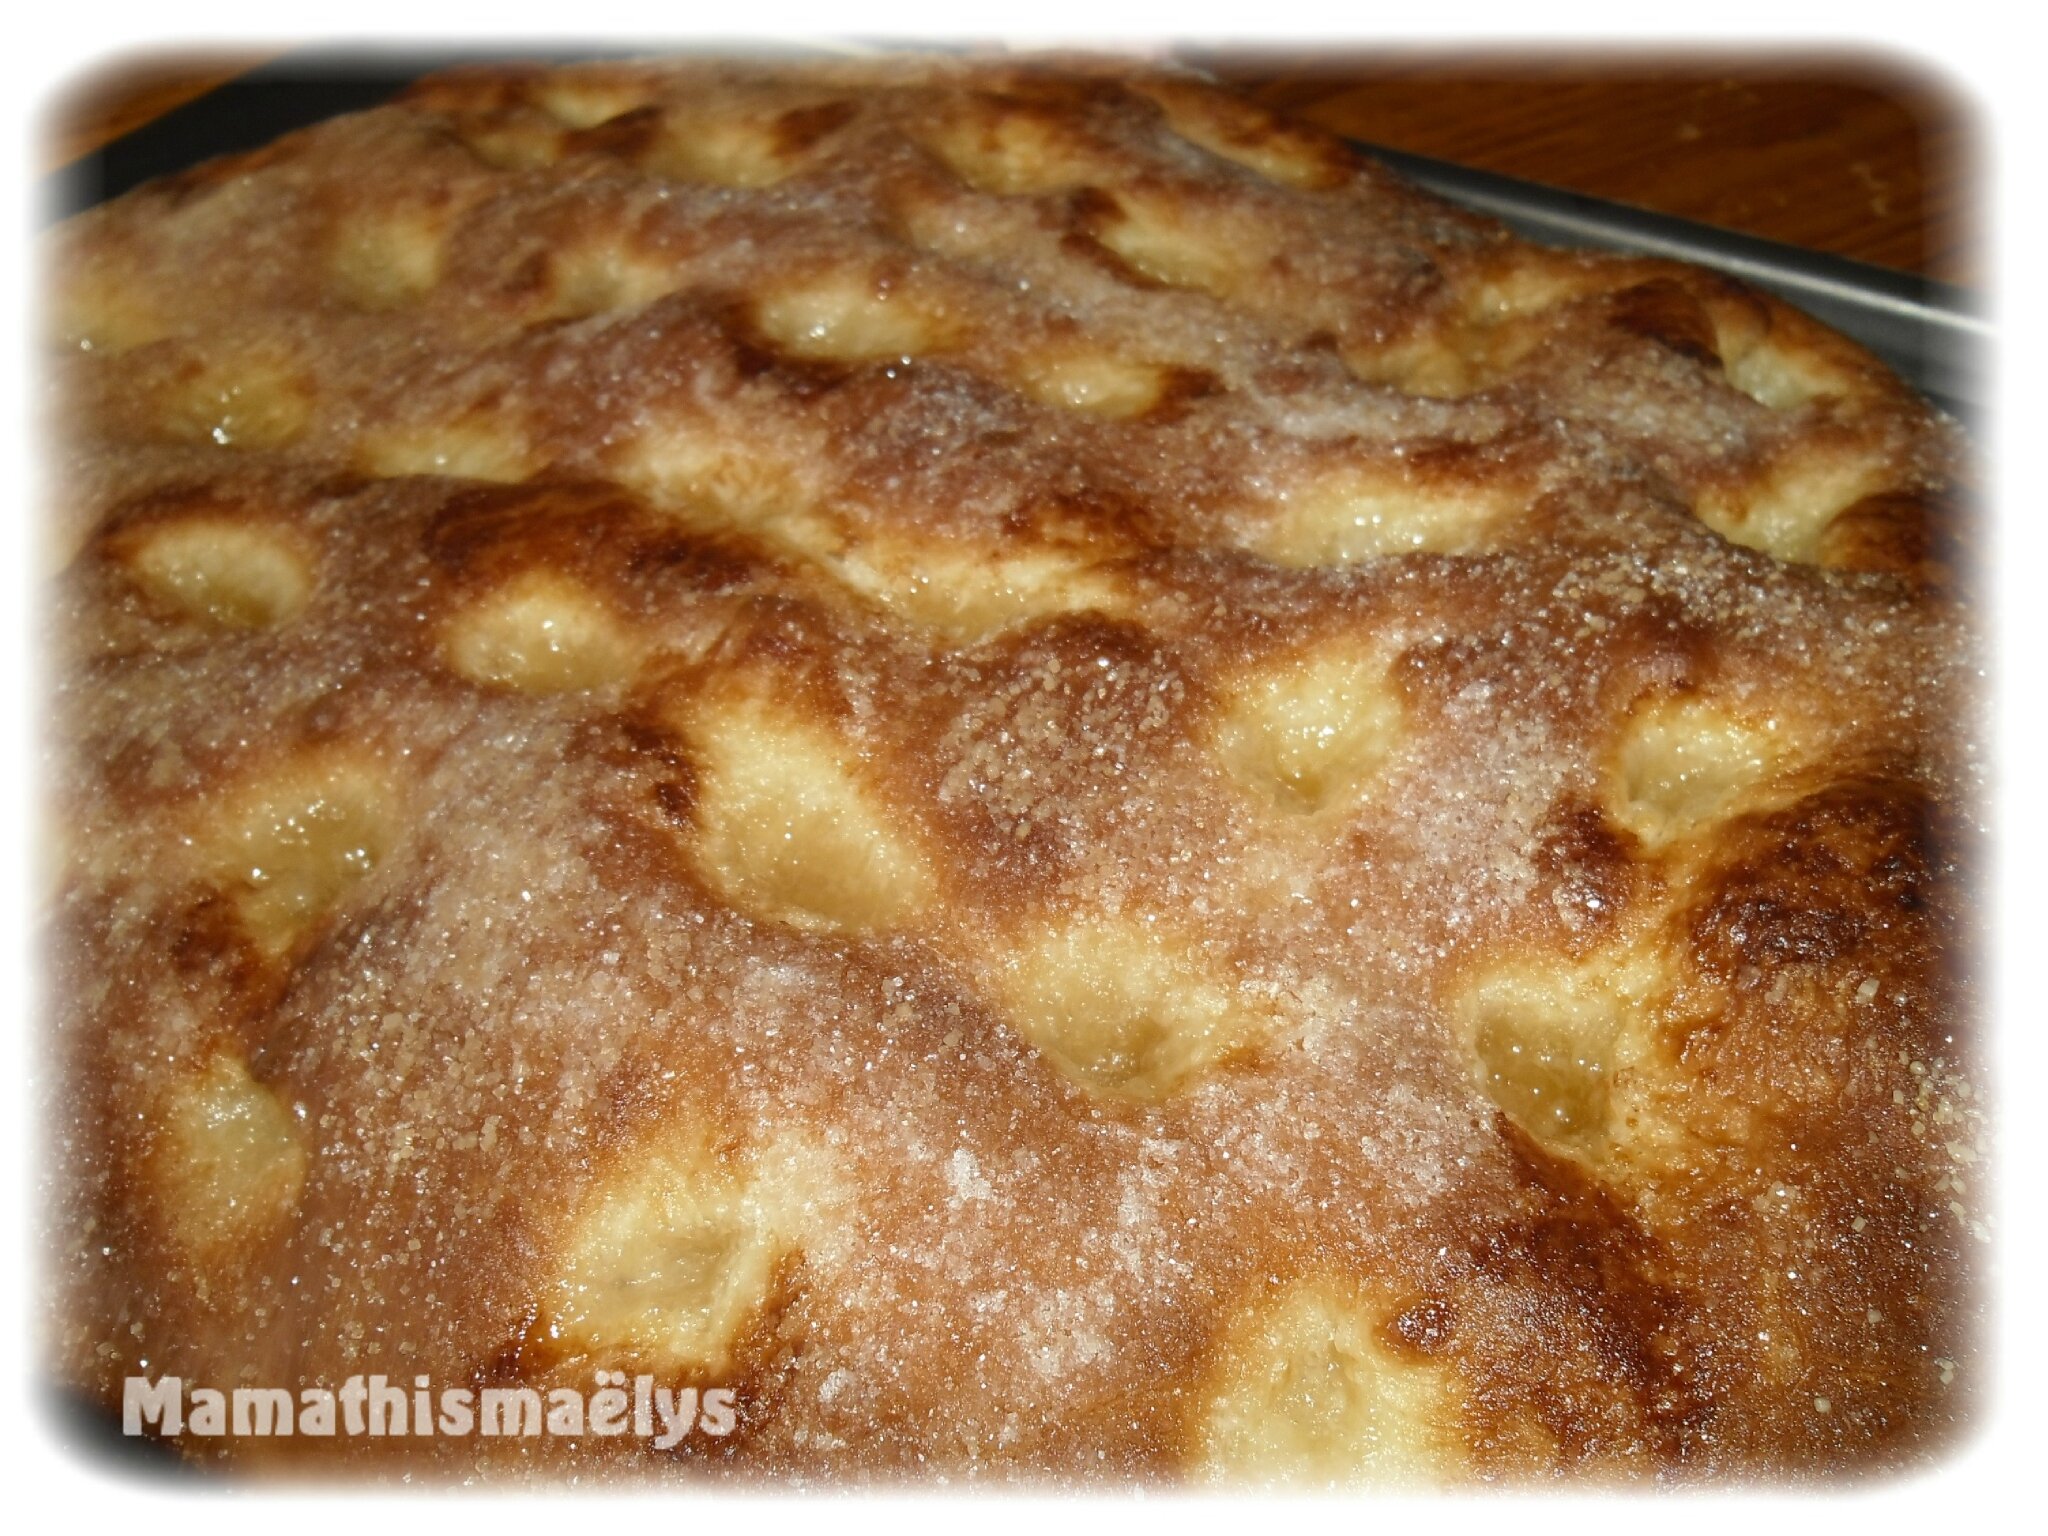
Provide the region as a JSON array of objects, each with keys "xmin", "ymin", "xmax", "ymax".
[{"xmin": 45, "ymin": 49, "xmax": 1980, "ymax": 285}]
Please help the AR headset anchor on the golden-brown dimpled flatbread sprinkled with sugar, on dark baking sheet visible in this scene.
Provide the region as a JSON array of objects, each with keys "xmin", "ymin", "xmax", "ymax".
[{"xmin": 47, "ymin": 59, "xmax": 1987, "ymax": 1483}]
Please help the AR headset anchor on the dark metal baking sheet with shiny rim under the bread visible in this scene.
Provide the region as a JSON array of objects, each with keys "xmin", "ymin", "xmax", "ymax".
[{"xmin": 51, "ymin": 45, "xmax": 1991, "ymax": 418}]
